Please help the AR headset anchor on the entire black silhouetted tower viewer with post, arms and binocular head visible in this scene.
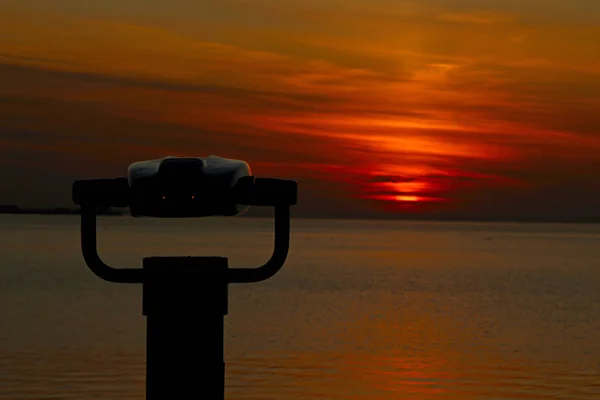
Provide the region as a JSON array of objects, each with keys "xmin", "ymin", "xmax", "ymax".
[{"xmin": 73, "ymin": 156, "xmax": 298, "ymax": 400}]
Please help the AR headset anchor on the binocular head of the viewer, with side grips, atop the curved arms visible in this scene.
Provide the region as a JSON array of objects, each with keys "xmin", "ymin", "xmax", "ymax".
[{"xmin": 73, "ymin": 156, "xmax": 298, "ymax": 218}]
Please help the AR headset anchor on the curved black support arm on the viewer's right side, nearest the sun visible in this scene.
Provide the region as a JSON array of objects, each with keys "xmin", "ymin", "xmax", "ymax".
[{"xmin": 227, "ymin": 206, "xmax": 290, "ymax": 283}]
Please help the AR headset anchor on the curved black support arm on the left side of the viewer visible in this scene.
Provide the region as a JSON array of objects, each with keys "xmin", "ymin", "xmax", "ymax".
[{"xmin": 81, "ymin": 206, "xmax": 144, "ymax": 283}]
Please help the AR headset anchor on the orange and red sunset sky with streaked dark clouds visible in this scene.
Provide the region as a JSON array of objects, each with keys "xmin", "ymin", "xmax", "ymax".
[{"xmin": 0, "ymin": 0, "xmax": 600, "ymax": 221}]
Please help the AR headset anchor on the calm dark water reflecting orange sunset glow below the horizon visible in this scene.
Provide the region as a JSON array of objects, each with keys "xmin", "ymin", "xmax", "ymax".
[{"xmin": 0, "ymin": 215, "xmax": 600, "ymax": 400}]
